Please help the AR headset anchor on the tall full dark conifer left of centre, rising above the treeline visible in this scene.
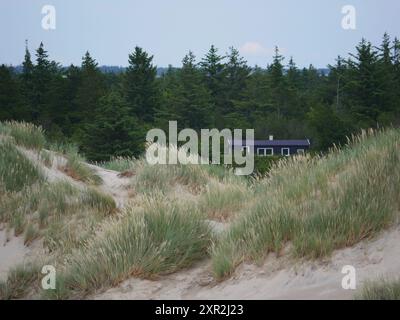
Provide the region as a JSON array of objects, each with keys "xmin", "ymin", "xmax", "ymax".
[{"xmin": 124, "ymin": 47, "xmax": 159, "ymax": 123}]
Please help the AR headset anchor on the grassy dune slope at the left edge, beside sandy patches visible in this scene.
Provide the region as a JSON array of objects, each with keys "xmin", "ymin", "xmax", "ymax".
[{"xmin": 0, "ymin": 122, "xmax": 116, "ymax": 251}]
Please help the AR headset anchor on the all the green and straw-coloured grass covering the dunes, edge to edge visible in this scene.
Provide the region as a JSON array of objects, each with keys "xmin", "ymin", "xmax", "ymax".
[{"xmin": 0, "ymin": 121, "xmax": 400, "ymax": 298}]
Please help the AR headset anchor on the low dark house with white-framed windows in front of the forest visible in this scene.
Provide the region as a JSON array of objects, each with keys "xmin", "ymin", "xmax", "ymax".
[{"xmin": 232, "ymin": 136, "xmax": 310, "ymax": 156}]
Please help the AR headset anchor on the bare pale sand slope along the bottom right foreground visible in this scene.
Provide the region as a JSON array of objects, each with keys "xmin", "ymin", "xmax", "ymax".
[{"xmin": 92, "ymin": 227, "xmax": 400, "ymax": 299}]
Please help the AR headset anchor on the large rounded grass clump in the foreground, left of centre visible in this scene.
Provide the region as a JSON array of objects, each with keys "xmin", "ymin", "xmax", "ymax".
[{"xmin": 46, "ymin": 199, "xmax": 211, "ymax": 298}]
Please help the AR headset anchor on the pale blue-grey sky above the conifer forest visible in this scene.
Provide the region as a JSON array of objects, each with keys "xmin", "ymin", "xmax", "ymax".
[{"xmin": 0, "ymin": 0, "xmax": 400, "ymax": 68}]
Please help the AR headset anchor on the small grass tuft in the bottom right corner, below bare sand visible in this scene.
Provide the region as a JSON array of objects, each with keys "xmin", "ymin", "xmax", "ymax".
[{"xmin": 356, "ymin": 279, "xmax": 400, "ymax": 300}]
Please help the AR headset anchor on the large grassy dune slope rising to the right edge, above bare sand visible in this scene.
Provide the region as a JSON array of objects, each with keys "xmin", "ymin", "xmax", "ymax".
[{"xmin": 212, "ymin": 130, "xmax": 400, "ymax": 279}]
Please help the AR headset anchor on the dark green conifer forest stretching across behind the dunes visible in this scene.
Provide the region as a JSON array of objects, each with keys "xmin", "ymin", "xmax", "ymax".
[{"xmin": 0, "ymin": 34, "xmax": 400, "ymax": 160}]
